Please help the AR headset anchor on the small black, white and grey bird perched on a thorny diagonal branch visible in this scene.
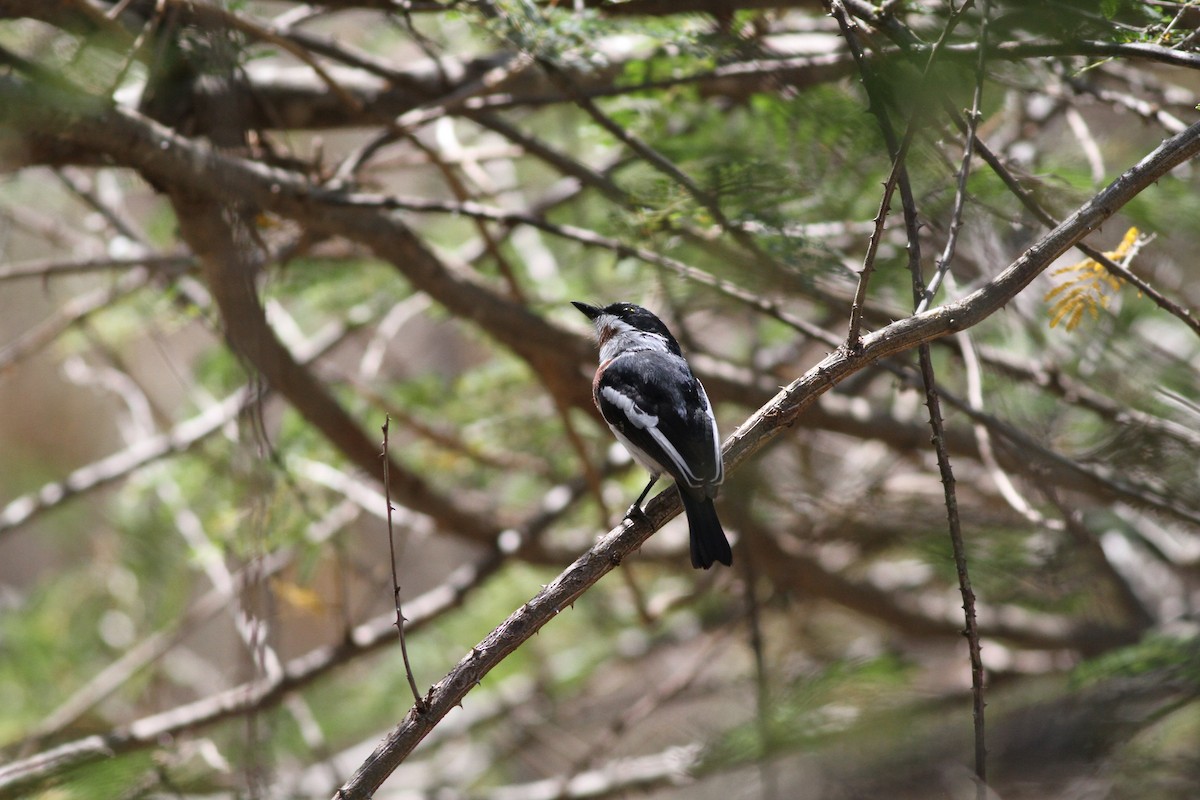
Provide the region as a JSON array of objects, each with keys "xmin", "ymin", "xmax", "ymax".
[{"xmin": 571, "ymin": 301, "xmax": 733, "ymax": 570}]
